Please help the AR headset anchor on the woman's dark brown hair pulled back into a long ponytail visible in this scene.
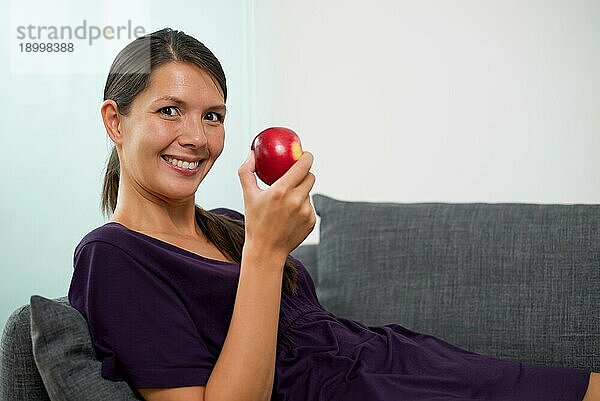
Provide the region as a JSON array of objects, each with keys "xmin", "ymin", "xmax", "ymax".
[{"xmin": 101, "ymin": 28, "xmax": 298, "ymax": 294}]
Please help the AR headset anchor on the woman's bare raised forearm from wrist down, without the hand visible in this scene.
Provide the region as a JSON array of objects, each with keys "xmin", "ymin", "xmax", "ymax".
[{"xmin": 204, "ymin": 247, "xmax": 287, "ymax": 401}]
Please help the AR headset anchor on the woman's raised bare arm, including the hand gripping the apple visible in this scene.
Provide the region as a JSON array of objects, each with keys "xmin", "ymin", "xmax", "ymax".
[{"xmin": 139, "ymin": 152, "xmax": 316, "ymax": 401}]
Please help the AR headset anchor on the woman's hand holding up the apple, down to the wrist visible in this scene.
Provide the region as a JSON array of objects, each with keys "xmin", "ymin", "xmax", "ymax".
[{"xmin": 238, "ymin": 151, "xmax": 316, "ymax": 268}]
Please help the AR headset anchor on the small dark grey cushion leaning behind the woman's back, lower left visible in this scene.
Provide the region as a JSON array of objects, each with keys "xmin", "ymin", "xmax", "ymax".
[{"xmin": 30, "ymin": 295, "xmax": 142, "ymax": 401}]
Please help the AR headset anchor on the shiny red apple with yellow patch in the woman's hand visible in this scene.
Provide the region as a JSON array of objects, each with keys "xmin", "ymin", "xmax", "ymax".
[{"xmin": 251, "ymin": 127, "xmax": 302, "ymax": 185}]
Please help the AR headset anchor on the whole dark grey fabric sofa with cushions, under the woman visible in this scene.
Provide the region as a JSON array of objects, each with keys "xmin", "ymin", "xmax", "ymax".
[{"xmin": 0, "ymin": 195, "xmax": 600, "ymax": 401}]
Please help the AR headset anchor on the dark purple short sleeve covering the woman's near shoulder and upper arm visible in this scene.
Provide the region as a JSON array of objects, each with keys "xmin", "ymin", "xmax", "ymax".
[{"xmin": 69, "ymin": 241, "xmax": 218, "ymax": 388}]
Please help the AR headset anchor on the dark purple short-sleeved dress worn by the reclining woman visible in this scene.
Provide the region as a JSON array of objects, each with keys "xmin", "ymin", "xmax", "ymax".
[{"xmin": 69, "ymin": 209, "xmax": 589, "ymax": 401}]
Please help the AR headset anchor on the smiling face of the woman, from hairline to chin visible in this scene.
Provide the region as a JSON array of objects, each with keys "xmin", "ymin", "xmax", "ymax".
[{"xmin": 117, "ymin": 62, "xmax": 225, "ymax": 201}]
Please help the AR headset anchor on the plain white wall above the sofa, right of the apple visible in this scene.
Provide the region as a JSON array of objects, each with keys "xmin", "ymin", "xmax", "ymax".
[{"xmin": 254, "ymin": 0, "xmax": 600, "ymax": 242}]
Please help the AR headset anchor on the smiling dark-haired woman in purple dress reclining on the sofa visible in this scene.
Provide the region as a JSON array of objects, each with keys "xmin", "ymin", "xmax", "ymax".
[{"xmin": 69, "ymin": 29, "xmax": 600, "ymax": 401}]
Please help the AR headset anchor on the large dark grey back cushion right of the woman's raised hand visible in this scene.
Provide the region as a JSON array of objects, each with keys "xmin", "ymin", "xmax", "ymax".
[{"xmin": 313, "ymin": 195, "xmax": 600, "ymax": 370}]
